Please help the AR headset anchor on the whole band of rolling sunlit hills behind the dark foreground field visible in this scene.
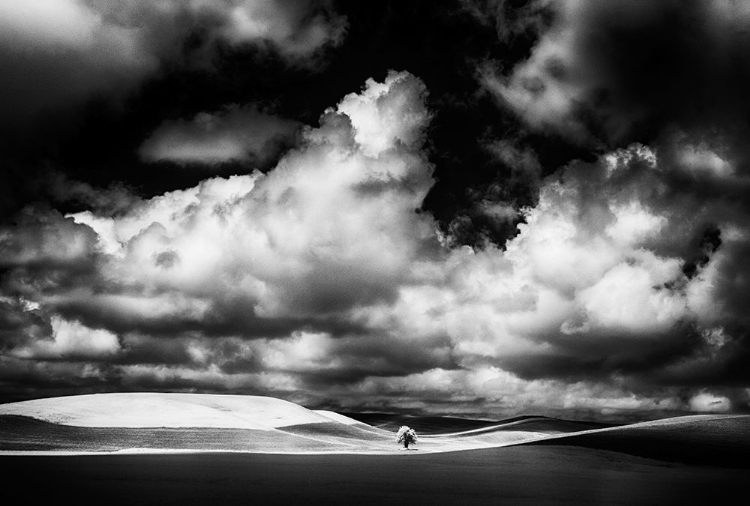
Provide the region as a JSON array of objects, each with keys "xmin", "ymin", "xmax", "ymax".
[{"xmin": 0, "ymin": 393, "xmax": 750, "ymax": 468}]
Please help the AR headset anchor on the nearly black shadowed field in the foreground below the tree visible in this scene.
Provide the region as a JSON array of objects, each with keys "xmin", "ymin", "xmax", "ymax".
[{"xmin": 0, "ymin": 446, "xmax": 750, "ymax": 506}]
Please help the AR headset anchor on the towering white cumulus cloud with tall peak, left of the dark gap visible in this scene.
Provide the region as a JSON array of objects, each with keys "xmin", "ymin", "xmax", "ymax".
[{"xmin": 4, "ymin": 69, "xmax": 437, "ymax": 334}]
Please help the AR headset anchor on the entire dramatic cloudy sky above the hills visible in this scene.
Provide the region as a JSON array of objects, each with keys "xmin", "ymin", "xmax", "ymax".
[{"xmin": 0, "ymin": 0, "xmax": 750, "ymax": 420}]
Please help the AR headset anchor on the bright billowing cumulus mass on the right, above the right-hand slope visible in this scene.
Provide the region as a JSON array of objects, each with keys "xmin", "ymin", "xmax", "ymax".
[{"xmin": 446, "ymin": 146, "xmax": 748, "ymax": 374}]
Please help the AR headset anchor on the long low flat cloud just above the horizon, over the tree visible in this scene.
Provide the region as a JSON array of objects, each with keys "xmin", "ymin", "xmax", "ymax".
[{"xmin": 334, "ymin": 366, "xmax": 686, "ymax": 422}]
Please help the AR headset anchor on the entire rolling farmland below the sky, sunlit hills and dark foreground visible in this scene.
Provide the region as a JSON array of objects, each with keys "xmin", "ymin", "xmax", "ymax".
[{"xmin": 0, "ymin": 394, "xmax": 750, "ymax": 505}]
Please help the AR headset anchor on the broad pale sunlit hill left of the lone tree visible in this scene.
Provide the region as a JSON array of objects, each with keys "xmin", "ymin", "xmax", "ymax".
[{"xmin": 0, "ymin": 393, "xmax": 396, "ymax": 453}]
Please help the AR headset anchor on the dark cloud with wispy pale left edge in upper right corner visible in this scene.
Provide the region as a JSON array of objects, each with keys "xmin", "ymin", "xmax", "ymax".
[{"xmin": 483, "ymin": 0, "xmax": 750, "ymax": 145}]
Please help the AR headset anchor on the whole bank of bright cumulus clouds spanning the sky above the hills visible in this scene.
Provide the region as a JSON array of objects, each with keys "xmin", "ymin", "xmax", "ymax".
[{"xmin": 0, "ymin": 72, "xmax": 750, "ymax": 416}]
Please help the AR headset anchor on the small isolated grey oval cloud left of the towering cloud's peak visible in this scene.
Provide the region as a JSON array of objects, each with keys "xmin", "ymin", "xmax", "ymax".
[{"xmin": 139, "ymin": 107, "xmax": 300, "ymax": 166}]
